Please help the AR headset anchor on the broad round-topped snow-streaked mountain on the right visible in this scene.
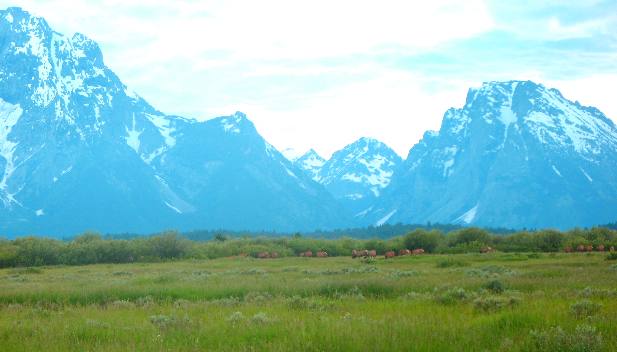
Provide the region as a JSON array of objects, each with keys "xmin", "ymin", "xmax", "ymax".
[{"xmin": 367, "ymin": 81, "xmax": 617, "ymax": 228}]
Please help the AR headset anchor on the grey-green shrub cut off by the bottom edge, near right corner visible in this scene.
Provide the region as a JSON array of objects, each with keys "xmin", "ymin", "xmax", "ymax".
[{"xmin": 527, "ymin": 324, "xmax": 603, "ymax": 352}]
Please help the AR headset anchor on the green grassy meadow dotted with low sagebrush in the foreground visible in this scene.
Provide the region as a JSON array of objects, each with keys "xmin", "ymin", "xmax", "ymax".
[{"xmin": 0, "ymin": 253, "xmax": 617, "ymax": 352}]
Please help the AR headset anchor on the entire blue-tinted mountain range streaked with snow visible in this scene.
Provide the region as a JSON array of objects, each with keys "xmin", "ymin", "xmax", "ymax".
[{"xmin": 0, "ymin": 8, "xmax": 617, "ymax": 236}]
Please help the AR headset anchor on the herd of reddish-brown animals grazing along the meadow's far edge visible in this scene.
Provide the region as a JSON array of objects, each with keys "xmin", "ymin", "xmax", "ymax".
[{"xmin": 249, "ymin": 244, "xmax": 615, "ymax": 259}]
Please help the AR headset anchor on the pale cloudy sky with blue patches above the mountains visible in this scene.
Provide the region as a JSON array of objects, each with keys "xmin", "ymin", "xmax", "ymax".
[{"xmin": 0, "ymin": 0, "xmax": 617, "ymax": 157}]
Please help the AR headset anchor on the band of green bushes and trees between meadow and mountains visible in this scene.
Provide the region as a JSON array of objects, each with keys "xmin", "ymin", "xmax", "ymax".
[{"xmin": 0, "ymin": 227, "xmax": 617, "ymax": 267}]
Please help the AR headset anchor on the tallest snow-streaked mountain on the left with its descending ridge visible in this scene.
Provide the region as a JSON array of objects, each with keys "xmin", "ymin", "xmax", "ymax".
[{"xmin": 0, "ymin": 8, "xmax": 346, "ymax": 235}]
